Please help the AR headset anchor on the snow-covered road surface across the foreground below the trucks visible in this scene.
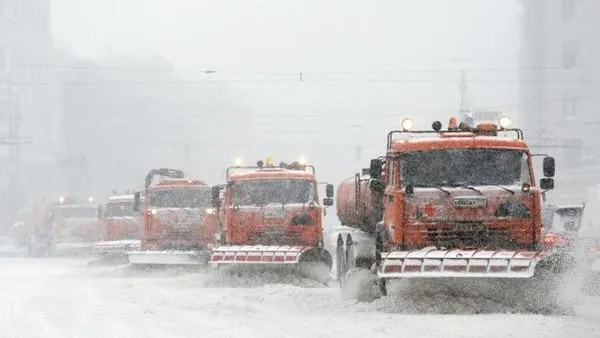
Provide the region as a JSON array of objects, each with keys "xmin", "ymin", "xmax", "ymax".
[{"xmin": 0, "ymin": 258, "xmax": 600, "ymax": 338}]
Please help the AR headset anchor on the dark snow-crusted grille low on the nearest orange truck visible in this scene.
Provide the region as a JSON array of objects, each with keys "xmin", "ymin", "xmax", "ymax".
[{"xmin": 426, "ymin": 223, "xmax": 516, "ymax": 249}]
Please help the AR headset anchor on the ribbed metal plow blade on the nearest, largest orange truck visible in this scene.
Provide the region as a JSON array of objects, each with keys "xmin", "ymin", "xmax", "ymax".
[{"xmin": 377, "ymin": 248, "xmax": 546, "ymax": 279}]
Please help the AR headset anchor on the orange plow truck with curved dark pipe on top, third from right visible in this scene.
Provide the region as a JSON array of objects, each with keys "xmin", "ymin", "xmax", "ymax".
[{"xmin": 126, "ymin": 168, "xmax": 218, "ymax": 266}]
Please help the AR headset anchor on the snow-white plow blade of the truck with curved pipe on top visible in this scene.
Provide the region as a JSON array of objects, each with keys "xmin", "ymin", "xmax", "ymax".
[{"xmin": 126, "ymin": 250, "xmax": 210, "ymax": 265}]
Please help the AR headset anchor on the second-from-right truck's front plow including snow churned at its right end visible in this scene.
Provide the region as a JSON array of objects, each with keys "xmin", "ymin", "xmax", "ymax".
[{"xmin": 210, "ymin": 245, "xmax": 333, "ymax": 285}]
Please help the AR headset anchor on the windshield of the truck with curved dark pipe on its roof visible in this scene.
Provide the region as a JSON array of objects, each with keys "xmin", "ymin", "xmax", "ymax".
[{"xmin": 147, "ymin": 188, "xmax": 212, "ymax": 208}]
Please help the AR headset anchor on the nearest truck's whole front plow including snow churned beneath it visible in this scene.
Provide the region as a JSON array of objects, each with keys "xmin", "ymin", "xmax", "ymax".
[{"xmin": 377, "ymin": 248, "xmax": 573, "ymax": 315}]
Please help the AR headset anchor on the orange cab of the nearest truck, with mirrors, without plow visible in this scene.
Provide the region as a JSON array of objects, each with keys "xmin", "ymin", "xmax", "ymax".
[{"xmin": 371, "ymin": 116, "xmax": 554, "ymax": 254}]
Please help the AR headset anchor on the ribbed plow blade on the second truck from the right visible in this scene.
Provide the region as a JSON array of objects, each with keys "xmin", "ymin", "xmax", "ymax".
[{"xmin": 210, "ymin": 245, "xmax": 312, "ymax": 265}]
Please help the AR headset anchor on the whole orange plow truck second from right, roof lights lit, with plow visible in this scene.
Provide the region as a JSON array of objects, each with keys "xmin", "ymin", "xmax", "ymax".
[{"xmin": 211, "ymin": 158, "xmax": 333, "ymax": 283}]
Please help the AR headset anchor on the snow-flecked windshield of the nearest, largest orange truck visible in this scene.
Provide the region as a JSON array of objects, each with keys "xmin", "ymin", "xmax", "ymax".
[{"xmin": 400, "ymin": 148, "xmax": 531, "ymax": 187}]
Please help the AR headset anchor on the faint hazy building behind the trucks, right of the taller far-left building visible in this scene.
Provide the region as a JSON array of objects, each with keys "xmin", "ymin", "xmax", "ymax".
[{"xmin": 60, "ymin": 57, "xmax": 253, "ymax": 198}]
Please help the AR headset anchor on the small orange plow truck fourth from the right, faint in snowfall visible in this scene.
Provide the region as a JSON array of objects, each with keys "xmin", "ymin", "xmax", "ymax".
[{"xmin": 94, "ymin": 194, "xmax": 143, "ymax": 261}]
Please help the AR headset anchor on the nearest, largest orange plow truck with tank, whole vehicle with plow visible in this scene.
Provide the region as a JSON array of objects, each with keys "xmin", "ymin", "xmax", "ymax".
[{"xmin": 336, "ymin": 116, "xmax": 570, "ymax": 311}]
